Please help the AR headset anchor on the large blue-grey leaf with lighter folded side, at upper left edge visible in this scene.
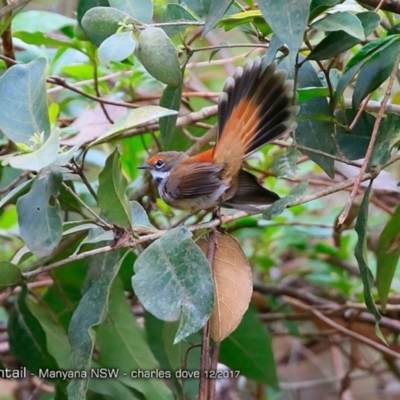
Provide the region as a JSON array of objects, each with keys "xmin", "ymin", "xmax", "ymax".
[{"xmin": 0, "ymin": 57, "xmax": 50, "ymax": 144}]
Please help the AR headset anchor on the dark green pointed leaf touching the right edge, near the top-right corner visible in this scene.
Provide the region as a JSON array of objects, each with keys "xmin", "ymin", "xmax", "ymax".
[{"xmin": 352, "ymin": 40, "xmax": 400, "ymax": 109}]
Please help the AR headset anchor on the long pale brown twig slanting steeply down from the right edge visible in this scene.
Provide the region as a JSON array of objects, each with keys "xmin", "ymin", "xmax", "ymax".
[{"xmin": 337, "ymin": 51, "xmax": 400, "ymax": 226}]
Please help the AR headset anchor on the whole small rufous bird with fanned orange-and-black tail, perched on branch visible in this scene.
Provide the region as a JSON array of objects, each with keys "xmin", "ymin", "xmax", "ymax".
[{"xmin": 139, "ymin": 58, "xmax": 297, "ymax": 213}]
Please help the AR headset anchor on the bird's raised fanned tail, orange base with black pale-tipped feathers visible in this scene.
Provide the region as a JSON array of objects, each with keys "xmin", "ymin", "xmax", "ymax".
[{"xmin": 214, "ymin": 58, "xmax": 297, "ymax": 169}]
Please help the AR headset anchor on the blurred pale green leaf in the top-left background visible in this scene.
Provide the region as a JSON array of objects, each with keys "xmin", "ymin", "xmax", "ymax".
[{"xmin": 12, "ymin": 10, "xmax": 76, "ymax": 33}]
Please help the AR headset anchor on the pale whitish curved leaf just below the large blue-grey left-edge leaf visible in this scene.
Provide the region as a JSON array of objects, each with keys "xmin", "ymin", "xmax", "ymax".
[{"xmin": 8, "ymin": 129, "xmax": 60, "ymax": 171}]
